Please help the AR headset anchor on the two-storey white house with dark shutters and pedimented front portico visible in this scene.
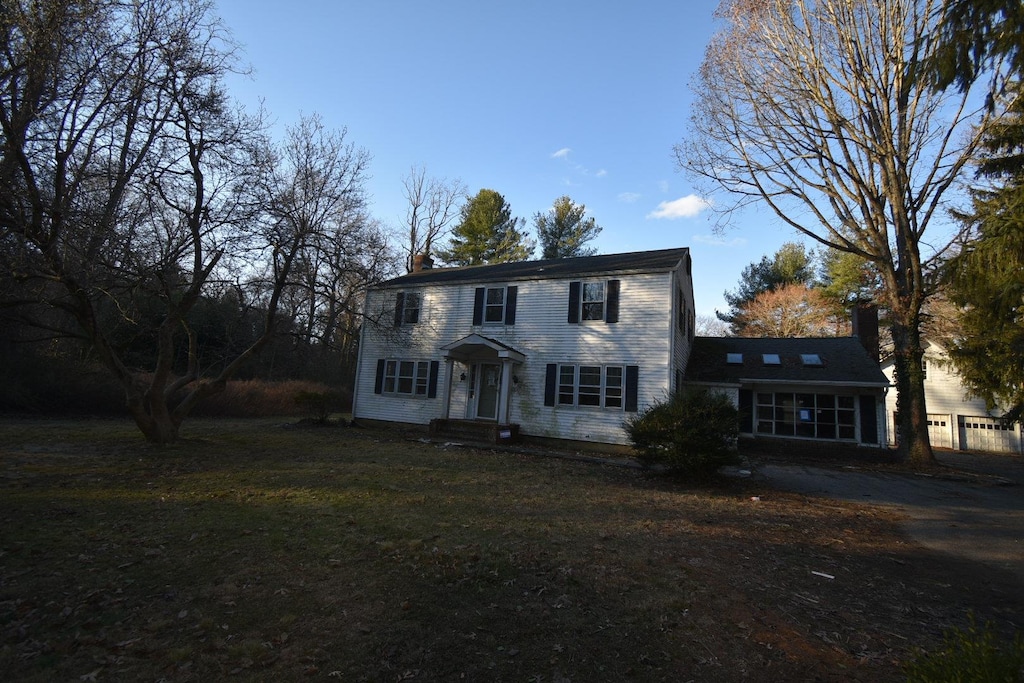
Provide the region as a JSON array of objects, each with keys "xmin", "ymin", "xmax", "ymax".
[{"xmin": 352, "ymin": 249, "xmax": 695, "ymax": 444}]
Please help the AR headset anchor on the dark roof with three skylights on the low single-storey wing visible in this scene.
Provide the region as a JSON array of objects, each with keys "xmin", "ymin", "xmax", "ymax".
[{"xmin": 686, "ymin": 337, "xmax": 889, "ymax": 387}]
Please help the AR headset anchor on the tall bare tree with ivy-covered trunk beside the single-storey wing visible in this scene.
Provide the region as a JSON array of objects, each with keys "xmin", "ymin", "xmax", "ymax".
[{"xmin": 676, "ymin": 0, "xmax": 987, "ymax": 464}]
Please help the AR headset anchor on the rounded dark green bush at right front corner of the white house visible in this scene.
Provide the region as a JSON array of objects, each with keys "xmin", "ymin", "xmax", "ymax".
[{"xmin": 626, "ymin": 388, "xmax": 739, "ymax": 478}]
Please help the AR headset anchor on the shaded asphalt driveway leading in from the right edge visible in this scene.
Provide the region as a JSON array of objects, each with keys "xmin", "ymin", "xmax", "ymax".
[{"xmin": 757, "ymin": 452, "xmax": 1024, "ymax": 586}]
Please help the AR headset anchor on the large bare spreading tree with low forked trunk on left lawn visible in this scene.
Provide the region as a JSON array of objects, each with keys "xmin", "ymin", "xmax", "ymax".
[{"xmin": 0, "ymin": 0, "xmax": 380, "ymax": 443}]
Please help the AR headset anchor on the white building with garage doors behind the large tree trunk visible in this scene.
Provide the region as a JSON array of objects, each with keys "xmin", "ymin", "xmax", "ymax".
[{"xmin": 882, "ymin": 340, "xmax": 1024, "ymax": 455}]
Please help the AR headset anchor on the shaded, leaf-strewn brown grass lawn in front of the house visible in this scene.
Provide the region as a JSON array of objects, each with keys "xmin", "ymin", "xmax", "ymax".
[{"xmin": 0, "ymin": 420, "xmax": 1022, "ymax": 682}]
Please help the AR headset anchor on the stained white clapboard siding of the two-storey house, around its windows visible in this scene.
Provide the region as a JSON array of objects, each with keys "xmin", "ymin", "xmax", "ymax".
[{"xmin": 355, "ymin": 264, "xmax": 693, "ymax": 443}]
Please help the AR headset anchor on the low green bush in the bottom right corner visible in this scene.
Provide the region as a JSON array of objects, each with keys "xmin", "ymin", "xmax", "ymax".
[{"xmin": 904, "ymin": 615, "xmax": 1024, "ymax": 683}]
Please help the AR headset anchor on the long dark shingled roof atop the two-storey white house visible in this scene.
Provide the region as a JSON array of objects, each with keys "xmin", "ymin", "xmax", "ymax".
[{"xmin": 378, "ymin": 247, "xmax": 689, "ymax": 288}]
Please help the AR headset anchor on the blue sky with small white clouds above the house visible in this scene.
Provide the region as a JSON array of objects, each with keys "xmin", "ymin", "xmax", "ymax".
[{"xmin": 217, "ymin": 0, "xmax": 790, "ymax": 314}]
